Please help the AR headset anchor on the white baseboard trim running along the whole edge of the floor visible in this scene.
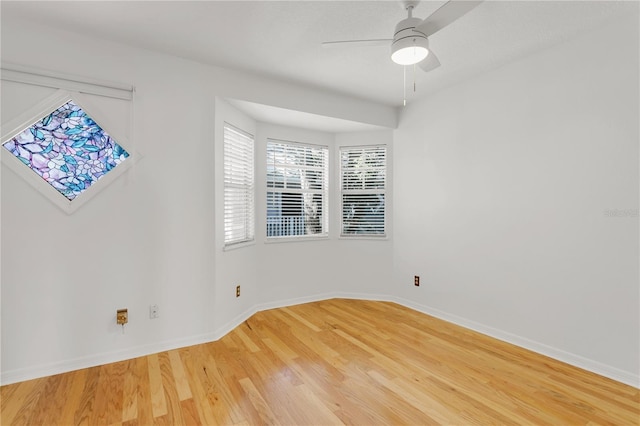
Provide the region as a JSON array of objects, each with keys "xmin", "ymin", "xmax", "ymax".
[{"xmin": 0, "ymin": 292, "xmax": 640, "ymax": 389}]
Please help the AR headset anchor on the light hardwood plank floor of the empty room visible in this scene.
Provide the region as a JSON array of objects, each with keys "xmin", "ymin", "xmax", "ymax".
[{"xmin": 0, "ymin": 299, "xmax": 640, "ymax": 425}]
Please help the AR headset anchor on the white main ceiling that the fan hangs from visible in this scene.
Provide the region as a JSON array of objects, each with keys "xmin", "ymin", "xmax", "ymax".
[{"xmin": 1, "ymin": 0, "xmax": 637, "ymax": 110}]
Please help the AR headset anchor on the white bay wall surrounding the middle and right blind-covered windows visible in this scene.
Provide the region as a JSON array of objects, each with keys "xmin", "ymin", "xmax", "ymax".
[{"xmin": 251, "ymin": 123, "xmax": 393, "ymax": 306}]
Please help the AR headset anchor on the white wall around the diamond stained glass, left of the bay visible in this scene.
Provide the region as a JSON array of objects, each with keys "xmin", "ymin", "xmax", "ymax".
[{"xmin": 2, "ymin": 30, "xmax": 220, "ymax": 383}]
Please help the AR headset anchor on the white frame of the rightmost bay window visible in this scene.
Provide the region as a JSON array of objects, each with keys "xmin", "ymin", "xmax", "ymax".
[{"xmin": 337, "ymin": 144, "xmax": 389, "ymax": 240}]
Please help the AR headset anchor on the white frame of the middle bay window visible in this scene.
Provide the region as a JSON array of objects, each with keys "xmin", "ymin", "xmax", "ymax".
[{"xmin": 264, "ymin": 138, "xmax": 331, "ymax": 243}]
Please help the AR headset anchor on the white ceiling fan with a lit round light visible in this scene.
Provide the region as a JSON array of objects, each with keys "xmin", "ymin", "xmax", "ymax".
[{"xmin": 322, "ymin": 0, "xmax": 482, "ymax": 72}]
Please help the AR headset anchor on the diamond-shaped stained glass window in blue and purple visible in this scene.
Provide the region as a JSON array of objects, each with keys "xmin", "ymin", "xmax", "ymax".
[{"xmin": 3, "ymin": 100, "xmax": 129, "ymax": 201}]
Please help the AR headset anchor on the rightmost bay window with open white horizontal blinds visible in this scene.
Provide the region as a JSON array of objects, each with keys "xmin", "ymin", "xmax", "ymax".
[{"xmin": 340, "ymin": 146, "xmax": 387, "ymax": 236}]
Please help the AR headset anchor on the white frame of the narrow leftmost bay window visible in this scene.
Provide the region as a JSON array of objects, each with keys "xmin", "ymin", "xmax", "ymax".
[{"xmin": 222, "ymin": 121, "xmax": 256, "ymax": 249}]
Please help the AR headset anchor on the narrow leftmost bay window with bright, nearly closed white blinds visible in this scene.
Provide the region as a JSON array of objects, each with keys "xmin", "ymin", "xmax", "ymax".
[{"xmin": 223, "ymin": 123, "xmax": 255, "ymax": 245}]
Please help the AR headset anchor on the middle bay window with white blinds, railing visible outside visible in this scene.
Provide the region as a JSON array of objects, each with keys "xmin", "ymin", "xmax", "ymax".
[{"xmin": 267, "ymin": 139, "xmax": 329, "ymax": 238}]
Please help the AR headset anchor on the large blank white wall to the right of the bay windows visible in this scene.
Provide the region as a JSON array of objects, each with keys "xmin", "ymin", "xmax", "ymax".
[{"xmin": 394, "ymin": 15, "xmax": 640, "ymax": 386}]
